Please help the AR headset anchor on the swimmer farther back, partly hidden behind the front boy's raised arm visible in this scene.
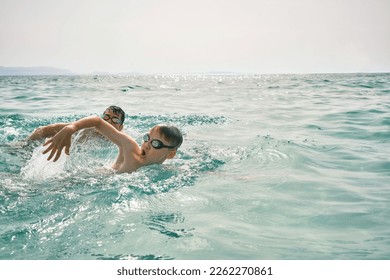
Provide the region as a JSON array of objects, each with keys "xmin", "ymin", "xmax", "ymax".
[{"xmin": 27, "ymin": 106, "xmax": 126, "ymax": 141}]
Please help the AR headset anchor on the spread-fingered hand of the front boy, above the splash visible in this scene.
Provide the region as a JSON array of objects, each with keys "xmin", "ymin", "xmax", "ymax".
[{"xmin": 43, "ymin": 125, "xmax": 74, "ymax": 162}]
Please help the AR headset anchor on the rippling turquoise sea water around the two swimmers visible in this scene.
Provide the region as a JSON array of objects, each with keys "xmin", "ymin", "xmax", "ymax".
[{"xmin": 0, "ymin": 74, "xmax": 390, "ymax": 259}]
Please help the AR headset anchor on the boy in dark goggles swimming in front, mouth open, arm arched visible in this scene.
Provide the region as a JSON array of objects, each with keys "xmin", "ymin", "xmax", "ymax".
[{"xmin": 43, "ymin": 116, "xmax": 183, "ymax": 173}]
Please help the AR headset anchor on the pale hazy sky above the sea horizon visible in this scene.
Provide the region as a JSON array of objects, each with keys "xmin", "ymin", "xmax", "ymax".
[{"xmin": 0, "ymin": 0, "xmax": 390, "ymax": 73}]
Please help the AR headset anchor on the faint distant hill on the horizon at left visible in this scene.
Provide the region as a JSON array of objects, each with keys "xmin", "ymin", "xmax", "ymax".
[{"xmin": 0, "ymin": 66, "xmax": 75, "ymax": 76}]
